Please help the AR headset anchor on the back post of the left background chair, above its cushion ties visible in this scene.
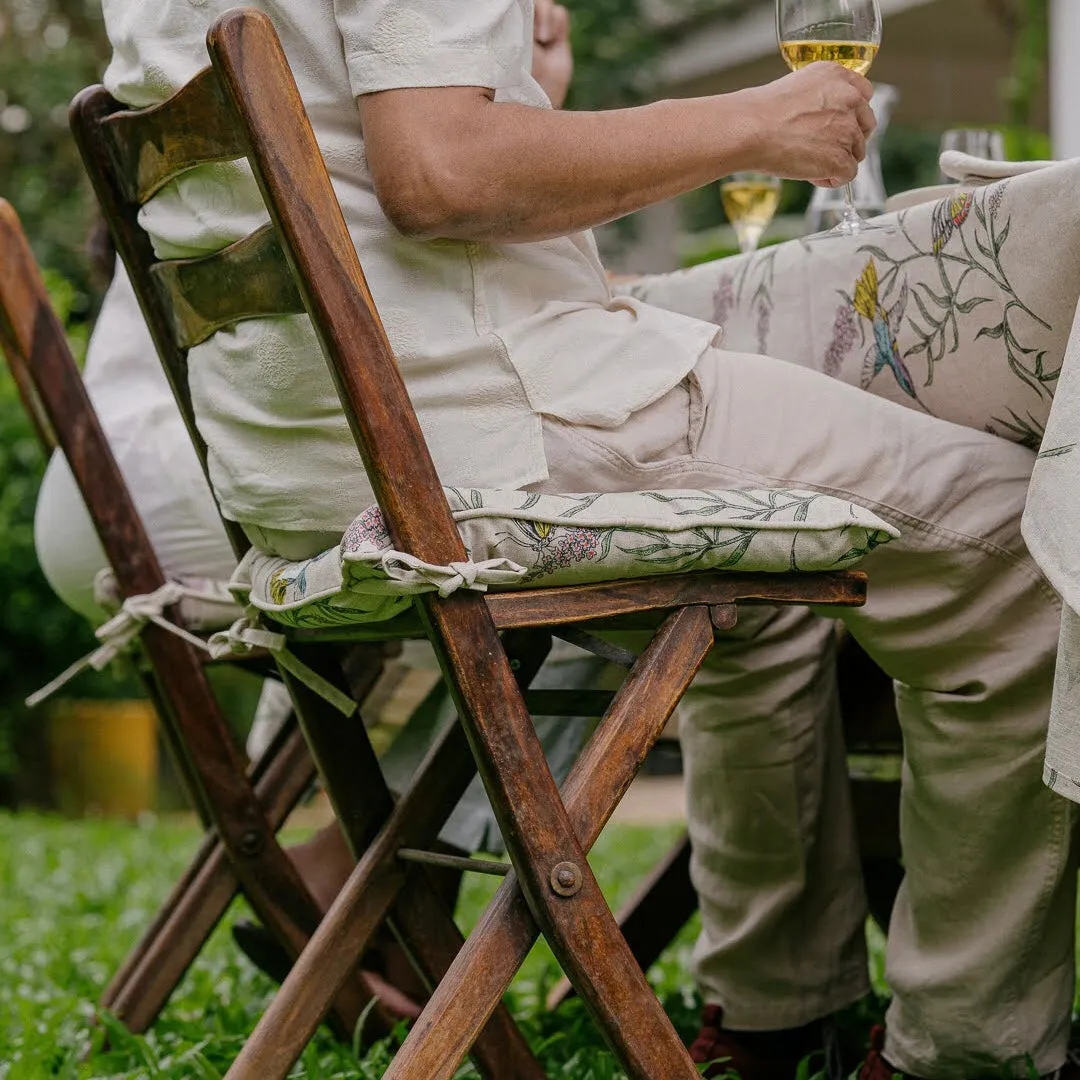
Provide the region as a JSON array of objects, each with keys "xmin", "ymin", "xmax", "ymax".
[{"xmin": 0, "ymin": 200, "xmax": 165, "ymax": 596}]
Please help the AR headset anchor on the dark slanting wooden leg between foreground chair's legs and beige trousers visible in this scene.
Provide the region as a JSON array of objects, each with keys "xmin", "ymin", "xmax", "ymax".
[{"xmin": 546, "ymin": 833, "xmax": 698, "ymax": 1012}]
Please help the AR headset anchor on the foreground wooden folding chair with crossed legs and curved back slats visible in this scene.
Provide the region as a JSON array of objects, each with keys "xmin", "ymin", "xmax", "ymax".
[{"xmin": 72, "ymin": 10, "xmax": 885, "ymax": 1080}]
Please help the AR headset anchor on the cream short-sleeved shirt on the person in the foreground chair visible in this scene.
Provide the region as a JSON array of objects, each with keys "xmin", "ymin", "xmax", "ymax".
[{"xmin": 103, "ymin": 0, "xmax": 717, "ymax": 530}]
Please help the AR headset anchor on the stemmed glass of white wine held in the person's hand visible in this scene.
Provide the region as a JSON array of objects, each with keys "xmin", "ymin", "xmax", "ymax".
[{"xmin": 777, "ymin": 0, "xmax": 881, "ymax": 237}]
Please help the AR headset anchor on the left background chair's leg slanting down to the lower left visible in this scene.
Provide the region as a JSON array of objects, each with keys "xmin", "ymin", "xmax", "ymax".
[{"xmin": 99, "ymin": 724, "xmax": 315, "ymax": 1034}]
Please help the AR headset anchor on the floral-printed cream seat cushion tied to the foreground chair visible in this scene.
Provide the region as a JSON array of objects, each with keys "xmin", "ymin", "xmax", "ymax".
[{"xmin": 232, "ymin": 488, "xmax": 899, "ymax": 626}]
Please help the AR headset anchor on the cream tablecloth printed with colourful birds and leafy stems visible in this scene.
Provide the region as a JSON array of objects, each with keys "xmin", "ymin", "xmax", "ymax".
[{"xmin": 627, "ymin": 161, "xmax": 1080, "ymax": 448}]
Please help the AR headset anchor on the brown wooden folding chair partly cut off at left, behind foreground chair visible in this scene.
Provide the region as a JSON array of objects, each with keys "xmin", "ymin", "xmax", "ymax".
[{"xmin": 0, "ymin": 200, "xmax": 408, "ymax": 1034}]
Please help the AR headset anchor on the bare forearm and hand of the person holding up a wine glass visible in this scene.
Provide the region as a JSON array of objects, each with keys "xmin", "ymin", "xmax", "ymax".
[{"xmin": 359, "ymin": 64, "xmax": 875, "ymax": 242}]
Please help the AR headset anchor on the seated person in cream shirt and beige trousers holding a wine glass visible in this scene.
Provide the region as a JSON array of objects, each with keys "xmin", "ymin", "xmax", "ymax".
[{"xmin": 95, "ymin": 0, "xmax": 1080, "ymax": 1080}]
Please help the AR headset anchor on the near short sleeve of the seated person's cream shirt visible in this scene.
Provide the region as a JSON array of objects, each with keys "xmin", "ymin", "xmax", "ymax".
[{"xmin": 334, "ymin": 0, "xmax": 532, "ymax": 97}]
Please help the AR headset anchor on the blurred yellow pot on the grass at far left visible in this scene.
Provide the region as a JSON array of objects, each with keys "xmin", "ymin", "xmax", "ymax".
[{"xmin": 49, "ymin": 701, "xmax": 158, "ymax": 818}]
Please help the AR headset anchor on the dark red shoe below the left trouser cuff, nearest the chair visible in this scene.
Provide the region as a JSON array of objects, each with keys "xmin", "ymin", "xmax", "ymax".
[{"xmin": 690, "ymin": 1005, "xmax": 824, "ymax": 1080}]
